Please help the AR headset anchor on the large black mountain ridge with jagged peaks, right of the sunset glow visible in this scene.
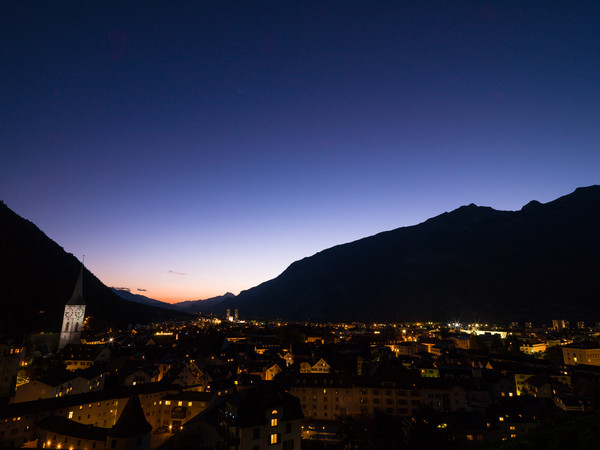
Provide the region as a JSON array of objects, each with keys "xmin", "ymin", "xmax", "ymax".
[{"xmin": 215, "ymin": 186, "xmax": 600, "ymax": 322}]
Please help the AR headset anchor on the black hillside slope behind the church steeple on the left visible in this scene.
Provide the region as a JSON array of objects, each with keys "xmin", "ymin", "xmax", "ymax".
[{"xmin": 0, "ymin": 202, "xmax": 189, "ymax": 338}]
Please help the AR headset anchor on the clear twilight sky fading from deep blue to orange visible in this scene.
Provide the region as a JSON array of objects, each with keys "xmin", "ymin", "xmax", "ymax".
[{"xmin": 0, "ymin": 0, "xmax": 600, "ymax": 301}]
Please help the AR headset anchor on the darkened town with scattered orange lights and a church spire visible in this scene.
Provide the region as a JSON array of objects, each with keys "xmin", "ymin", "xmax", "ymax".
[{"xmin": 0, "ymin": 273, "xmax": 600, "ymax": 450}]
